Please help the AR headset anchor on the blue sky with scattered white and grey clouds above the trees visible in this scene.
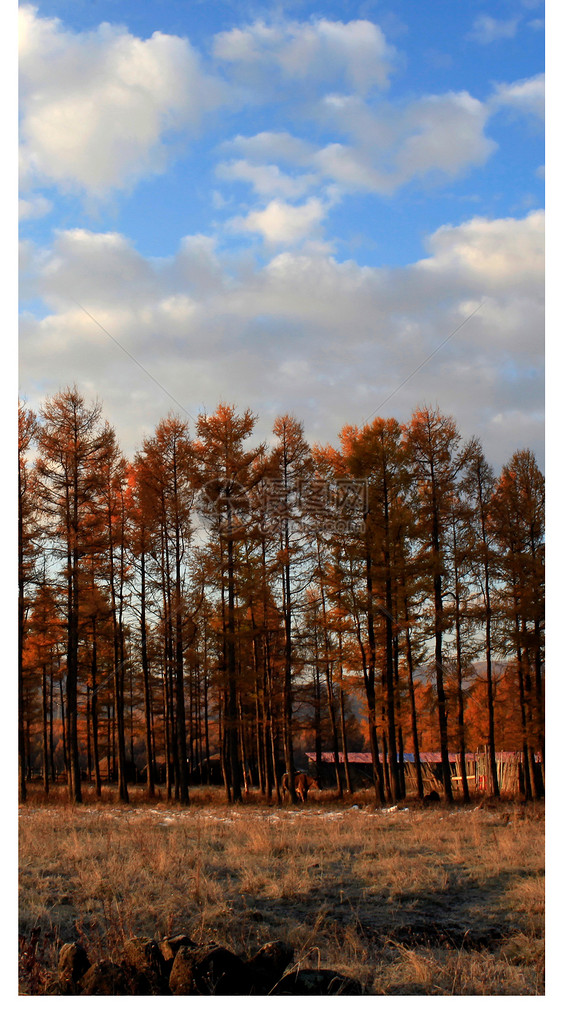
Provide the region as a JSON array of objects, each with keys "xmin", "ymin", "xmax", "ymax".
[{"xmin": 19, "ymin": 0, "xmax": 544, "ymax": 467}]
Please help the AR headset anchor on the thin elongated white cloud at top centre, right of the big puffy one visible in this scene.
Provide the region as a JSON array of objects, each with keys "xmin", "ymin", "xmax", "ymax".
[{"xmin": 214, "ymin": 18, "xmax": 396, "ymax": 93}]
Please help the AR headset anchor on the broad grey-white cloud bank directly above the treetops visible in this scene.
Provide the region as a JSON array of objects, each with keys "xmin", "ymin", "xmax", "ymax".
[{"xmin": 20, "ymin": 212, "xmax": 544, "ymax": 465}]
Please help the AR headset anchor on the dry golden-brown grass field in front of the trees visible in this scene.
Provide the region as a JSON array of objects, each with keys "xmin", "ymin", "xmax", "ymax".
[{"xmin": 19, "ymin": 789, "xmax": 544, "ymax": 996}]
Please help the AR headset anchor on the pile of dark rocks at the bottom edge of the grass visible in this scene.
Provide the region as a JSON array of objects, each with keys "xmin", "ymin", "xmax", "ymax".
[{"xmin": 51, "ymin": 934, "xmax": 363, "ymax": 997}]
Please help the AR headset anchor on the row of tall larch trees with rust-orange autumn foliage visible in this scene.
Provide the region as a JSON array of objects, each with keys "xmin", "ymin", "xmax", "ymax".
[{"xmin": 18, "ymin": 388, "xmax": 545, "ymax": 804}]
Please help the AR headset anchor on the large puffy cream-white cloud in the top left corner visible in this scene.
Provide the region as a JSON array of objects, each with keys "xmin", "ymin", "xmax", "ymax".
[{"xmin": 19, "ymin": 6, "xmax": 221, "ymax": 197}]
